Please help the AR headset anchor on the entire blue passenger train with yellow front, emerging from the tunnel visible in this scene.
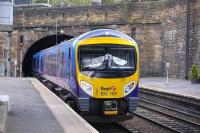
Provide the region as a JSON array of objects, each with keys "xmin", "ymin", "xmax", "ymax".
[{"xmin": 32, "ymin": 29, "xmax": 139, "ymax": 122}]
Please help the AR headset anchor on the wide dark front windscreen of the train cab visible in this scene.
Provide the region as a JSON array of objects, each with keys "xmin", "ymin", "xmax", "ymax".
[{"xmin": 78, "ymin": 44, "xmax": 137, "ymax": 78}]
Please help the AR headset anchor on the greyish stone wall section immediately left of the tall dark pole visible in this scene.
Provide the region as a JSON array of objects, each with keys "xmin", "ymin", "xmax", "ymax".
[{"xmin": 161, "ymin": 0, "xmax": 186, "ymax": 78}]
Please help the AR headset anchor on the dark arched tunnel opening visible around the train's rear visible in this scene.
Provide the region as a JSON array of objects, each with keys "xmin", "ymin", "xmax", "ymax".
[{"xmin": 22, "ymin": 34, "xmax": 73, "ymax": 77}]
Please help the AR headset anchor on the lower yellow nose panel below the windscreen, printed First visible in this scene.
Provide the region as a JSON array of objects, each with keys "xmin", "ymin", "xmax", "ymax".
[{"xmin": 77, "ymin": 72, "xmax": 138, "ymax": 98}]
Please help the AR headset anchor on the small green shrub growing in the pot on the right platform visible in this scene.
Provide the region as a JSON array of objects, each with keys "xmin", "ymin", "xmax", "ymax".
[{"xmin": 190, "ymin": 64, "xmax": 200, "ymax": 80}]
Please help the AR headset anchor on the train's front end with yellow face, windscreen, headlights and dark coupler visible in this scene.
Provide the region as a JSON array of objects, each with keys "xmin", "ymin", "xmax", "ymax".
[{"xmin": 76, "ymin": 31, "xmax": 139, "ymax": 122}]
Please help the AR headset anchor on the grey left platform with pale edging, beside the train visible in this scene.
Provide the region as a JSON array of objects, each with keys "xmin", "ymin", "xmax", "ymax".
[{"xmin": 0, "ymin": 78, "xmax": 97, "ymax": 133}]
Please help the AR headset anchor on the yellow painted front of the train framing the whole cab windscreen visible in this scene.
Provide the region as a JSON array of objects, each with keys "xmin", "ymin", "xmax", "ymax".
[{"xmin": 76, "ymin": 37, "xmax": 139, "ymax": 98}]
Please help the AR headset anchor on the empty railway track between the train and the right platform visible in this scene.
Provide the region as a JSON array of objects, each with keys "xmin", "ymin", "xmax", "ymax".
[{"xmin": 134, "ymin": 89, "xmax": 200, "ymax": 133}]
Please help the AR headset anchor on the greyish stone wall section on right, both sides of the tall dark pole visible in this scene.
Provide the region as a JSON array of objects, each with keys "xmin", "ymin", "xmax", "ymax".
[{"xmin": 161, "ymin": 0, "xmax": 200, "ymax": 78}]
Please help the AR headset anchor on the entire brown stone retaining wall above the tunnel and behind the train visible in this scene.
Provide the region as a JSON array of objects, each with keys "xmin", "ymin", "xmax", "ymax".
[{"xmin": 0, "ymin": 0, "xmax": 200, "ymax": 78}]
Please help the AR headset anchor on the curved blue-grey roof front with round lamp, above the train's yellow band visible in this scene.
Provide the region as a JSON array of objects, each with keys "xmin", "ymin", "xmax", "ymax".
[{"xmin": 76, "ymin": 29, "xmax": 137, "ymax": 44}]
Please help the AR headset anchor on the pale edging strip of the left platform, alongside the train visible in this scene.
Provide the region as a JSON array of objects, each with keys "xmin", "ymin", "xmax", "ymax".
[{"xmin": 30, "ymin": 78, "xmax": 97, "ymax": 133}]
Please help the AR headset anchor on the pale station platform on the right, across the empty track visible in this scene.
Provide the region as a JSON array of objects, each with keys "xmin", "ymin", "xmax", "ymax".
[{"xmin": 139, "ymin": 77, "xmax": 200, "ymax": 100}]
